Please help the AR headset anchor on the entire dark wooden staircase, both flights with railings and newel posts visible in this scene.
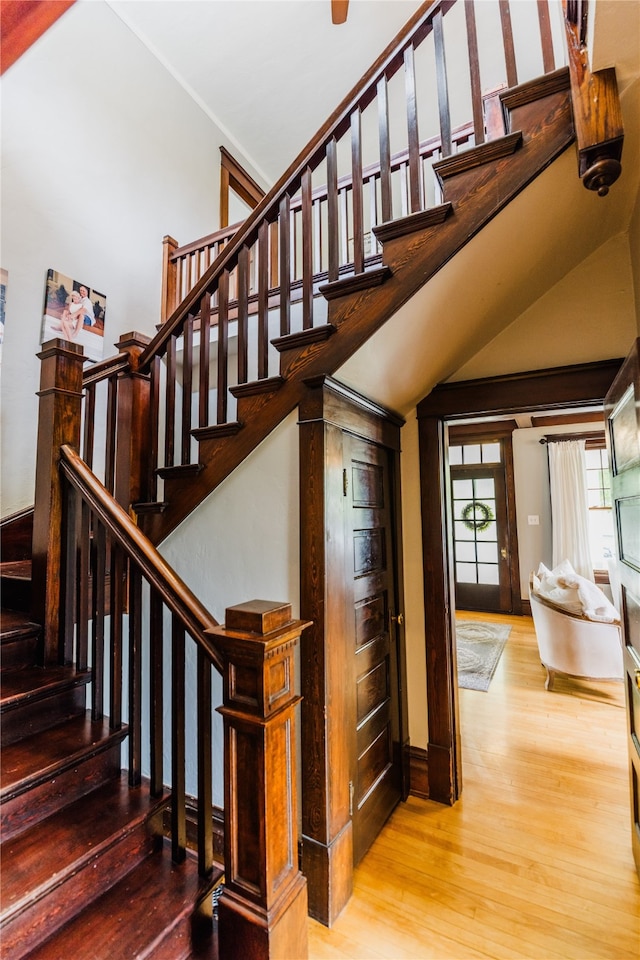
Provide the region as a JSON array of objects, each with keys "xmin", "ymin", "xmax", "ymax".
[{"xmin": 0, "ymin": 0, "xmax": 624, "ymax": 960}]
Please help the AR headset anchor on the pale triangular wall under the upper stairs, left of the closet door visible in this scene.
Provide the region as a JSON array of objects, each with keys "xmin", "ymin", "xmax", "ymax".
[{"xmin": 160, "ymin": 411, "xmax": 300, "ymax": 805}]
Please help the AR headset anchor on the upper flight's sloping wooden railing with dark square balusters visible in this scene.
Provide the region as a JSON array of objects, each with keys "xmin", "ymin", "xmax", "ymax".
[{"xmin": 75, "ymin": 0, "xmax": 558, "ymax": 542}]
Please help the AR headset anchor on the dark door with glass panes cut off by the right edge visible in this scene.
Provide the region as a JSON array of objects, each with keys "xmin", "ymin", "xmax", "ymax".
[{"xmin": 604, "ymin": 340, "xmax": 640, "ymax": 876}]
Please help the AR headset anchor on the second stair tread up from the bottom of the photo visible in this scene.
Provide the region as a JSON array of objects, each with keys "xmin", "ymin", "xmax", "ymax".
[{"xmin": 0, "ymin": 773, "xmax": 167, "ymax": 921}]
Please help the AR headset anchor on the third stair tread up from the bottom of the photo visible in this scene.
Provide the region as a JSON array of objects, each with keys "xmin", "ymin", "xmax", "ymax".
[{"xmin": 0, "ymin": 712, "xmax": 126, "ymax": 799}]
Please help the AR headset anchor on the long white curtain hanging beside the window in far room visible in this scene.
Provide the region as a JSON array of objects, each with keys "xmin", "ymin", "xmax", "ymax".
[{"xmin": 547, "ymin": 440, "xmax": 593, "ymax": 580}]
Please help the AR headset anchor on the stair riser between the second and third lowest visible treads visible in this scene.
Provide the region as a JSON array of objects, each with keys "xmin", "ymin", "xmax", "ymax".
[{"xmin": 0, "ymin": 741, "xmax": 120, "ymax": 840}]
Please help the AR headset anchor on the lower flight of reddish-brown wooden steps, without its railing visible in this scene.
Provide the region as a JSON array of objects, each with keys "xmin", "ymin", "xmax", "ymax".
[{"xmin": 0, "ymin": 609, "xmax": 222, "ymax": 960}]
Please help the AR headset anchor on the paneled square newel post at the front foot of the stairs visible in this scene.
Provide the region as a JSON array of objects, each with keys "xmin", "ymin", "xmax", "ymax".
[{"xmin": 210, "ymin": 600, "xmax": 309, "ymax": 960}]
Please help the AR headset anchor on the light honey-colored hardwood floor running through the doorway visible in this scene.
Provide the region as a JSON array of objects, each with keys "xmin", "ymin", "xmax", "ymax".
[{"xmin": 309, "ymin": 614, "xmax": 640, "ymax": 960}]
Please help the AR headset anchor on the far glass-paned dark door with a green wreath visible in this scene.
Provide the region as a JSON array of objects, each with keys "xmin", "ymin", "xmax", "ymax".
[{"xmin": 451, "ymin": 463, "xmax": 512, "ymax": 613}]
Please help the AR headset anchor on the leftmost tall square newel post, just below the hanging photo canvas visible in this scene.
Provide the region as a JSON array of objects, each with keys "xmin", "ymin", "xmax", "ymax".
[{"xmin": 31, "ymin": 340, "xmax": 84, "ymax": 664}]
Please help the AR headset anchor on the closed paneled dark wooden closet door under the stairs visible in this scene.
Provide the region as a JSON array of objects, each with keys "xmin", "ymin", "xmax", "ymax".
[{"xmin": 344, "ymin": 435, "xmax": 402, "ymax": 863}]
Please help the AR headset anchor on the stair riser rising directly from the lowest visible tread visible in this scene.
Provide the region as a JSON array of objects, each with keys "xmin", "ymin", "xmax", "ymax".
[{"xmin": 0, "ymin": 824, "xmax": 161, "ymax": 960}]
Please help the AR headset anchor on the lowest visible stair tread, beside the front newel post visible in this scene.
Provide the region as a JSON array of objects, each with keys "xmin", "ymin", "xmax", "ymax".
[{"xmin": 29, "ymin": 841, "xmax": 217, "ymax": 960}]
